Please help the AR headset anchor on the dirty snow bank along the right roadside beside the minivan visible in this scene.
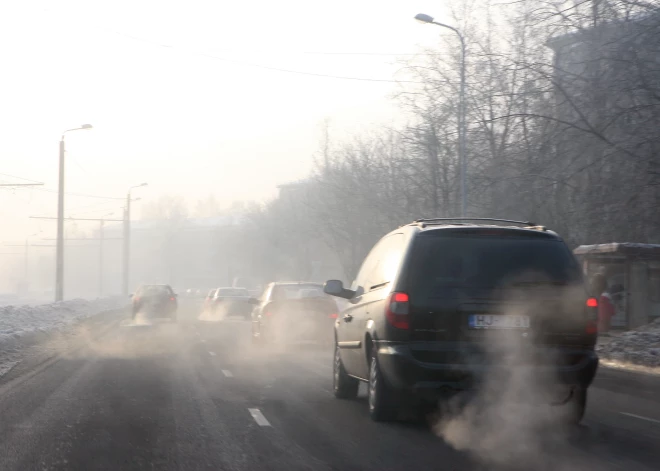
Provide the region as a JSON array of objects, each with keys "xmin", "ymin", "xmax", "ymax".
[{"xmin": 596, "ymin": 319, "xmax": 660, "ymax": 368}]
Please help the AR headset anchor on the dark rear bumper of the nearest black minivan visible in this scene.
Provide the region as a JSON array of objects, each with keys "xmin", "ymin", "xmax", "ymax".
[{"xmin": 376, "ymin": 342, "xmax": 598, "ymax": 395}]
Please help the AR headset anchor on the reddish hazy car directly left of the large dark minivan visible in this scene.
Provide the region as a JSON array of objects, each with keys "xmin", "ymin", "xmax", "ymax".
[{"xmin": 250, "ymin": 282, "xmax": 337, "ymax": 346}]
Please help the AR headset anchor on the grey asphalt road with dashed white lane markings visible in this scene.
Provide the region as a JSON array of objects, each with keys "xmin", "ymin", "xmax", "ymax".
[{"xmin": 0, "ymin": 304, "xmax": 660, "ymax": 471}]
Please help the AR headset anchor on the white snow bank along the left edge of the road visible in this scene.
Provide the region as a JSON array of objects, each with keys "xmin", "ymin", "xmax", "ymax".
[{"xmin": 0, "ymin": 297, "xmax": 126, "ymax": 343}]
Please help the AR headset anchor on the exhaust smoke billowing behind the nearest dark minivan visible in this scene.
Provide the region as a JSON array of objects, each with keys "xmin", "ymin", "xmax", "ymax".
[{"xmin": 432, "ymin": 287, "xmax": 585, "ymax": 471}]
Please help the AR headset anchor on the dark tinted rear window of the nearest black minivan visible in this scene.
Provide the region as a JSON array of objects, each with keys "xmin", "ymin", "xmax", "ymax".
[{"xmin": 408, "ymin": 234, "xmax": 581, "ymax": 300}]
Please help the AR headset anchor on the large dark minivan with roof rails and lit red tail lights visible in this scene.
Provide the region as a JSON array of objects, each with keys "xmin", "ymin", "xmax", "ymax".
[{"xmin": 324, "ymin": 218, "xmax": 598, "ymax": 423}]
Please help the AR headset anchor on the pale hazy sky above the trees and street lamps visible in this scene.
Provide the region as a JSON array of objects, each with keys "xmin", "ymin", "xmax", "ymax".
[{"xmin": 0, "ymin": 0, "xmax": 446, "ymax": 240}]
